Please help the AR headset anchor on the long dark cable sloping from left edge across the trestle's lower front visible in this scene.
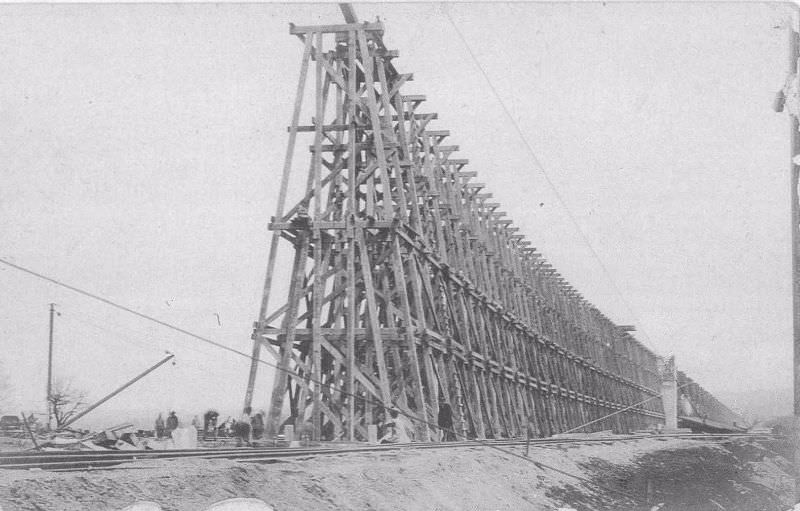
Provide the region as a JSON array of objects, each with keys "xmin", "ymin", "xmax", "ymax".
[{"xmin": 0, "ymin": 258, "xmax": 640, "ymax": 501}]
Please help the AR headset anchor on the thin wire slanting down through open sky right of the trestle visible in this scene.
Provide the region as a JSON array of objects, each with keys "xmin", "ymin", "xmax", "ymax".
[{"xmin": 442, "ymin": 4, "xmax": 653, "ymax": 344}]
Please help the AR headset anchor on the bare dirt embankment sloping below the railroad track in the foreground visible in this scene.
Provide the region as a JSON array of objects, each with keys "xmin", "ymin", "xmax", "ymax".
[{"xmin": 0, "ymin": 439, "xmax": 791, "ymax": 511}]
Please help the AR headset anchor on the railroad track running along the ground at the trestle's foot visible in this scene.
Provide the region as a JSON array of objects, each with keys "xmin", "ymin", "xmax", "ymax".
[{"xmin": 0, "ymin": 433, "xmax": 781, "ymax": 472}]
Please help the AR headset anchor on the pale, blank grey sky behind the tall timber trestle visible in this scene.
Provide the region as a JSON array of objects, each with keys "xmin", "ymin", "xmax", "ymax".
[{"xmin": 0, "ymin": 2, "xmax": 792, "ymax": 426}]
